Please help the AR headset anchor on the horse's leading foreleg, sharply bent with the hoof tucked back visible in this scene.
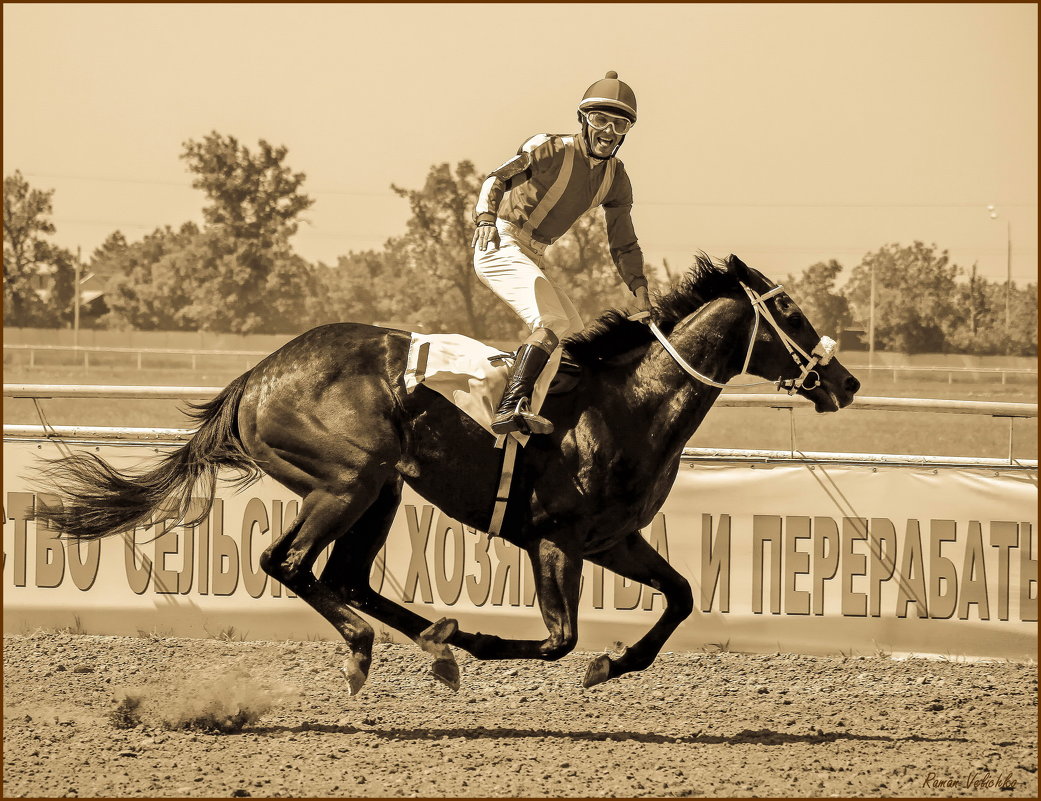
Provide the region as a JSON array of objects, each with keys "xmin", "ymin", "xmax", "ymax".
[{"xmin": 582, "ymin": 531, "xmax": 694, "ymax": 687}]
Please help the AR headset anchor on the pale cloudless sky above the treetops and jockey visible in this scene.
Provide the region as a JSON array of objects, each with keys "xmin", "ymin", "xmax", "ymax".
[{"xmin": 3, "ymin": 3, "xmax": 1038, "ymax": 284}]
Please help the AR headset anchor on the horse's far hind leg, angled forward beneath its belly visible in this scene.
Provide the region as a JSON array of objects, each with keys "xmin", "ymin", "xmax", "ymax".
[{"xmin": 322, "ymin": 479, "xmax": 459, "ymax": 690}]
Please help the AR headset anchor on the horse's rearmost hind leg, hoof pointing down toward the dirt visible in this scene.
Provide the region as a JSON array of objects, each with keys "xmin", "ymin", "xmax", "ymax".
[{"xmin": 260, "ymin": 490, "xmax": 387, "ymax": 695}]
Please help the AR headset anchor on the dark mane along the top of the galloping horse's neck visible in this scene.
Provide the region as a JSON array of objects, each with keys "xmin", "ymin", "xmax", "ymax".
[{"xmin": 564, "ymin": 253, "xmax": 736, "ymax": 365}]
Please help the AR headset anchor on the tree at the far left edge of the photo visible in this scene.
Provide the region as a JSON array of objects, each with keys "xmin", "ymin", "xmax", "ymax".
[{"xmin": 3, "ymin": 170, "xmax": 76, "ymax": 326}]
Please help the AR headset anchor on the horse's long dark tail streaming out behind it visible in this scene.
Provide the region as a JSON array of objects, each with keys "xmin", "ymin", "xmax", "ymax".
[{"xmin": 34, "ymin": 373, "xmax": 261, "ymax": 540}]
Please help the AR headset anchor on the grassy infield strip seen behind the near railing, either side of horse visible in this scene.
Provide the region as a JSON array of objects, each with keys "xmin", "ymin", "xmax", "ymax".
[{"xmin": 3, "ymin": 356, "xmax": 1038, "ymax": 458}]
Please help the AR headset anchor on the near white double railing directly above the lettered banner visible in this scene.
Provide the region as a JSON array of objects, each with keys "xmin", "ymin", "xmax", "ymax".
[{"xmin": 3, "ymin": 383, "xmax": 1038, "ymax": 465}]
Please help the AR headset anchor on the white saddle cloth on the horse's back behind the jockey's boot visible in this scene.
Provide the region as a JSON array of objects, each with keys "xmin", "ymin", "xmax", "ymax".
[{"xmin": 405, "ymin": 333, "xmax": 556, "ymax": 445}]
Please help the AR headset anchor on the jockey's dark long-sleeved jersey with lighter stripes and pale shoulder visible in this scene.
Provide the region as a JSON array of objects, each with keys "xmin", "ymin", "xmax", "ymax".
[{"xmin": 474, "ymin": 133, "xmax": 646, "ymax": 291}]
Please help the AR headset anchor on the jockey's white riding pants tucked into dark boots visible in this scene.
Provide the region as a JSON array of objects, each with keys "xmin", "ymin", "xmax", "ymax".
[{"xmin": 474, "ymin": 220, "xmax": 583, "ymax": 412}]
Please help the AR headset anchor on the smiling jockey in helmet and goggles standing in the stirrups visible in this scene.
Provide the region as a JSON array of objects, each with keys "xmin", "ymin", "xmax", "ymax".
[{"xmin": 471, "ymin": 72, "xmax": 650, "ymax": 434}]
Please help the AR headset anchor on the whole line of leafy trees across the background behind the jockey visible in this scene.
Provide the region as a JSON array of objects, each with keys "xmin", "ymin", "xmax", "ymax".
[{"xmin": 4, "ymin": 139, "xmax": 1038, "ymax": 355}]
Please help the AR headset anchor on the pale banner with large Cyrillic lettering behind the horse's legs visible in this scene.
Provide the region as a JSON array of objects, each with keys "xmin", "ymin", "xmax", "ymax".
[{"xmin": 3, "ymin": 441, "xmax": 1038, "ymax": 657}]
